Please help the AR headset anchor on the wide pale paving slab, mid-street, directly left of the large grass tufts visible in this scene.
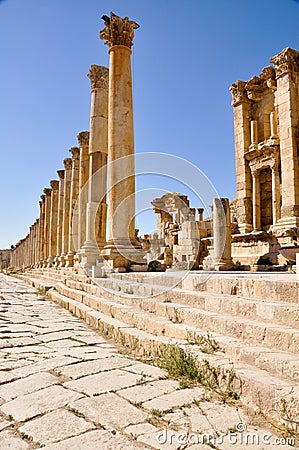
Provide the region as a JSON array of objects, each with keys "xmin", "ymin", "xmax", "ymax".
[{"xmin": 64, "ymin": 369, "xmax": 148, "ymax": 395}]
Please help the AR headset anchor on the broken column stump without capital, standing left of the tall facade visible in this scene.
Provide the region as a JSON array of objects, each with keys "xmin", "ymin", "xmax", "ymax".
[{"xmin": 213, "ymin": 198, "xmax": 233, "ymax": 270}]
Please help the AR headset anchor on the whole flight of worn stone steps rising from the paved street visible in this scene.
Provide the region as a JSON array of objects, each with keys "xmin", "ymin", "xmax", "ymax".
[{"xmin": 18, "ymin": 269, "xmax": 299, "ymax": 420}]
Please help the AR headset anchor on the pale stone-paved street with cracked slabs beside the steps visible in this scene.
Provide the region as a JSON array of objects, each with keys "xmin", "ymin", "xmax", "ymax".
[{"xmin": 0, "ymin": 274, "xmax": 297, "ymax": 450}]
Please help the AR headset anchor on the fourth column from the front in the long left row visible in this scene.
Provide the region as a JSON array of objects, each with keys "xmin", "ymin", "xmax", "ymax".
[{"xmin": 65, "ymin": 147, "xmax": 80, "ymax": 267}]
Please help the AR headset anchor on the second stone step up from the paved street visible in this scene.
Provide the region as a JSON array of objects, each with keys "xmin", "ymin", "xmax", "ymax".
[{"xmin": 52, "ymin": 283, "xmax": 299, "ymax": 381}]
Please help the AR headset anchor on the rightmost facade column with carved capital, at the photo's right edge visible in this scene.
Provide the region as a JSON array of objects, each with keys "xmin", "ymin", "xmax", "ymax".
[{"xmin": 270, "ymin": 48, "xmax": 299, "ymax": 229}]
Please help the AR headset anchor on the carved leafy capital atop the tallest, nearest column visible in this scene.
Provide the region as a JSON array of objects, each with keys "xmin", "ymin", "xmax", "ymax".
[{"xmin": 100, "ymin": 12, "xmax": 139, "ymax": 48}]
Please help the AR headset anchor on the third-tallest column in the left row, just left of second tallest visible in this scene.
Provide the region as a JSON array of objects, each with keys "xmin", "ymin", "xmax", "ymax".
[{"xmin": 77, "ymin": 131, "xmax": 89, "ymax": 258}]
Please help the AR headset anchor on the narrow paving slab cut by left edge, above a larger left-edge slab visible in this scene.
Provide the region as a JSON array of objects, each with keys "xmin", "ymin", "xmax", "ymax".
[{"xmin": 0, "ymin": 373, "xmax": 58, "ymax": 402}]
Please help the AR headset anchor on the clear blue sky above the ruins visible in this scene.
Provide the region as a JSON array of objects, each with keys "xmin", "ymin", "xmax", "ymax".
[{"xmin": 0, "ymin": 0, "xmax": 299, "ymax": 248}]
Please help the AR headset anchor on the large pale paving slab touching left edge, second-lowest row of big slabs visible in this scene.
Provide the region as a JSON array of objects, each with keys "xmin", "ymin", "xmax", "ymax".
[{"xmin": 0, "ymin": 386, "xmax": 82, "ymax": 422}]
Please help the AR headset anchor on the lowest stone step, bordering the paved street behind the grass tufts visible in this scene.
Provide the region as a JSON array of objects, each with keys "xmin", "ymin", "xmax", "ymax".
[{"xmin": 44, "ymin": 289, "xmax": 299, "ymax": 419}]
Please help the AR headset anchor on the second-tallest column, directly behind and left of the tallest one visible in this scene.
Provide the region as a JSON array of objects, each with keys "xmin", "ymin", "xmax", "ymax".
[{"xmin": 80, "ymin": 65, "xmax": 109, "ymax": 270}]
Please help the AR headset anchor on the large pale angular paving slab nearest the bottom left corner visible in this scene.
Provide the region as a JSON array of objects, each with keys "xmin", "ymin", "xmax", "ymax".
[{"xmin": 19, "ymin": 409, "xmax": 95, "ymax": 445}]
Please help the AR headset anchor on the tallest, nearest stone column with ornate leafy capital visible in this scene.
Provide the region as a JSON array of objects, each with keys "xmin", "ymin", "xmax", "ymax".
[{"xmin": 100, "ymin": 13, "xmax": 144, "ymax": 270}]
